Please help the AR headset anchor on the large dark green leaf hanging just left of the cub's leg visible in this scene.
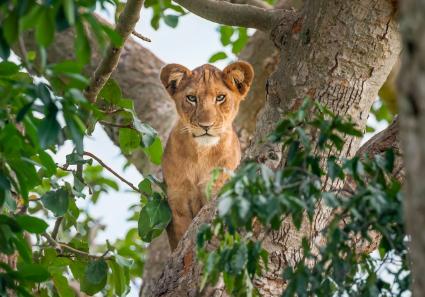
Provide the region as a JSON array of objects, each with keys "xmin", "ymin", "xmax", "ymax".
[{"xmin": 138, "ymin": 193, "xmax": 171, "ymax": 242}]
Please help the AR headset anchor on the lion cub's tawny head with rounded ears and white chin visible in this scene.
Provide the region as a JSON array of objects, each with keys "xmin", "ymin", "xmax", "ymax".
[{"xmin": 161, "ymin": 61, "xmax": 254, "ymax": 145}]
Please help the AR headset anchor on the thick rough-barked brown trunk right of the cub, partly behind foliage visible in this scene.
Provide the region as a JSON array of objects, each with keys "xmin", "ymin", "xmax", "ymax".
[{"xmin": 149, "ymin": 0, "xmax": 400, "ymax": 296}]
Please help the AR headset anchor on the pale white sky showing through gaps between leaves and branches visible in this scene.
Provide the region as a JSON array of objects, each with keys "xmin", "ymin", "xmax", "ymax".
[{"xmin": 57, "ymin": 5, "xmax": 385, "ymax": 297}]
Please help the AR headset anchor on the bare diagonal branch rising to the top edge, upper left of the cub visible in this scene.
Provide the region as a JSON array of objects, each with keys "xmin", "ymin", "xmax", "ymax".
[{"xmin": 85, "ymin": 0, "xmax": 144, "ymax": 102}]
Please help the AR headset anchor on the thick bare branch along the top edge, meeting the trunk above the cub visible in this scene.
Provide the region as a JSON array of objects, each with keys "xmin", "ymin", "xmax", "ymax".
[{"xmin": 175, "ymin": 0, "xmax": 285, "ymax": 32}]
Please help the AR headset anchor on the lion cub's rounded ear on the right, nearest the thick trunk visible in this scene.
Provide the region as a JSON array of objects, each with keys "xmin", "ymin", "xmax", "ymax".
[{"xmin": 223, "ymin": 61, "xmax": 254, "ymax": 97}]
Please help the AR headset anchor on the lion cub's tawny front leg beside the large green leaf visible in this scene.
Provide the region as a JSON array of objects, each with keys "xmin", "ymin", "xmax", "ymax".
[{"xmin": 167, "ymin": 188, "xmax": 197, "ymax": 251}]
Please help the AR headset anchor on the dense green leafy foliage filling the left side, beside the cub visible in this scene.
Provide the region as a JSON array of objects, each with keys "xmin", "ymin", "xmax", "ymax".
[{"xmin": 0, "ymin": 0, "xmax": 169, "ymax": 296}]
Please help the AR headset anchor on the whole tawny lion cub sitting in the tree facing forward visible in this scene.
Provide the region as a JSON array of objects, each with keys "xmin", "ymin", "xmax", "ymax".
[{"xmin": 161, "ymin": 61, "xmax": 254, "ymax": 250}]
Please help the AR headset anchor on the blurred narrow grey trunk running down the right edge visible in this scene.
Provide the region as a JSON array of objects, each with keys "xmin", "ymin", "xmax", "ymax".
[{"xmin": 398, "ymin": 0, "xmax": 425, "ymax": 297}]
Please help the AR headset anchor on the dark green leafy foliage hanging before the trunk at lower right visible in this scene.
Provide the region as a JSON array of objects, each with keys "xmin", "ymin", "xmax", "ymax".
[{"xmin": 197, "ymin": 100, "xmax": 410, "ymax": 296}]
